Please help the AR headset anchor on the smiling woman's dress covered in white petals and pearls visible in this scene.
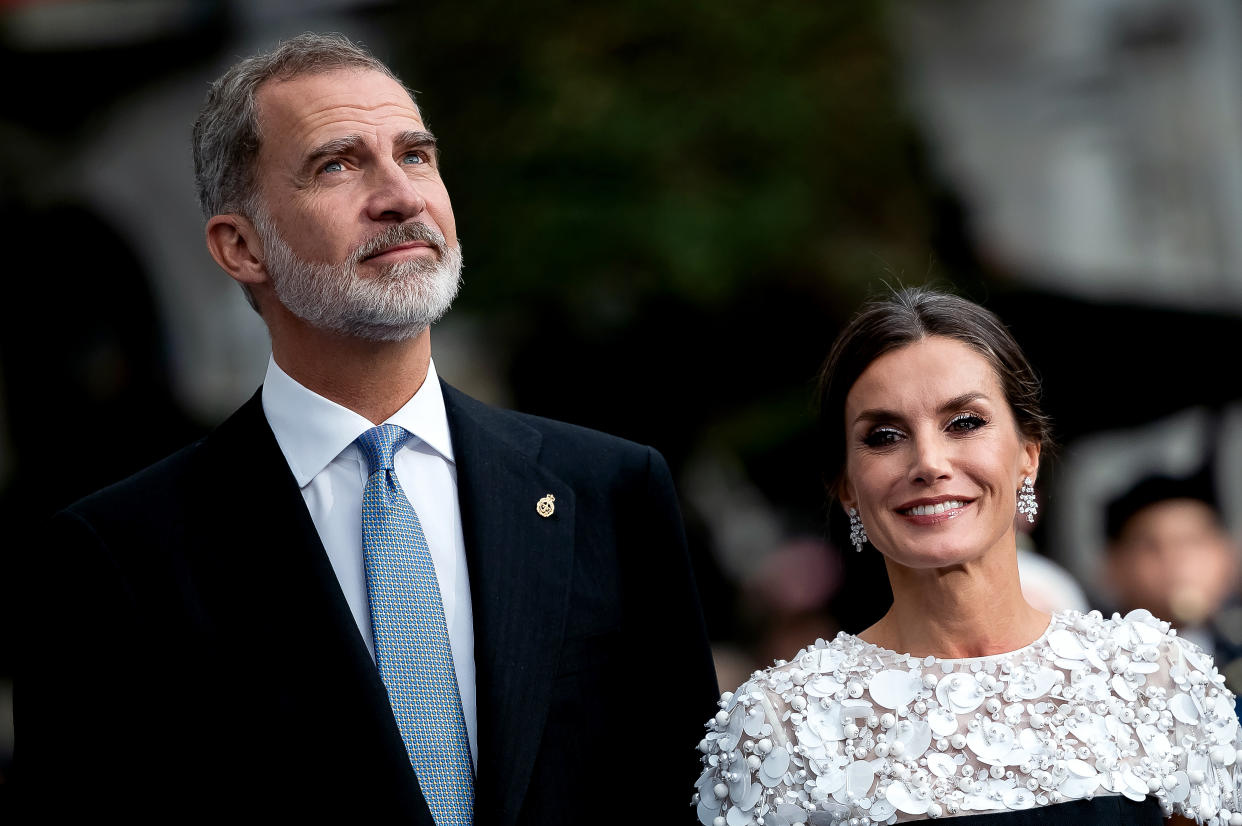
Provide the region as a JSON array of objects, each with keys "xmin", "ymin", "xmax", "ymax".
[{"xmin": 696, "ymin": 611, "xmax": 1242, "ymax": 826}]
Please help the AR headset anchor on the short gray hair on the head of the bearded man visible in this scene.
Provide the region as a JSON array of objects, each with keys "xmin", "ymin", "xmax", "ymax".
[{"xmin": 194, "ymin": 32, "xmax": 414, "ymax": 217}]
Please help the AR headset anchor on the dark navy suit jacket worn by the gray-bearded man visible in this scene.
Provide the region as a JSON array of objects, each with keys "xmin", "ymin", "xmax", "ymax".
[{"xmin": 14, "ymin": 385, "xmax": 717, "ymax": 826}]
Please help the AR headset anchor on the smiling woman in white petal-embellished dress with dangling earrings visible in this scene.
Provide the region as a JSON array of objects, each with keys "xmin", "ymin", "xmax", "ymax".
[{"xmin": 697, "ymin": 289, "xmax": 1242, "ymax": 826}]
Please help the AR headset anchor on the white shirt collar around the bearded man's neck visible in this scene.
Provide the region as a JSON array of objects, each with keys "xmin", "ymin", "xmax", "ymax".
[{"xmin": 262, "ymin": 358, "xmax": 455, "ymax": 487}]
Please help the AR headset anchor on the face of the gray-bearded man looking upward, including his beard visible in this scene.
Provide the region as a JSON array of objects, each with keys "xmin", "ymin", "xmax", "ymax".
[{"xmin": 253, "ymin": 70, "xmax": 461, "ymax": 340}]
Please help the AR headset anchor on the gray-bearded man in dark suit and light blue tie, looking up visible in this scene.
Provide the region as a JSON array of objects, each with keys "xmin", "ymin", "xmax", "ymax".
[{"xmin": 15, "ymin": 35, "xmax": 717, "ymax": 826}]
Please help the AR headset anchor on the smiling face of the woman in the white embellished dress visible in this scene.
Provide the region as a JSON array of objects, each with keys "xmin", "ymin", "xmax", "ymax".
[{"xmin": 841, "ymin": 337, "xmax": 1040, "ymax": 569}]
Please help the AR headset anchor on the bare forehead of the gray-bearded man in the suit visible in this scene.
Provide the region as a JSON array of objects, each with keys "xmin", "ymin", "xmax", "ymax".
[{"xmin": 257, "ymin": 68, "xmax": 425, "ymax": 142}]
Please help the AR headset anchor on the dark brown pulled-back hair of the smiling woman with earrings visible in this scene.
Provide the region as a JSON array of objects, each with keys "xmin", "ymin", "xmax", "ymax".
[{"xmin": 818, "ymin": 287, "xmax": 1052, "ymax": 496}]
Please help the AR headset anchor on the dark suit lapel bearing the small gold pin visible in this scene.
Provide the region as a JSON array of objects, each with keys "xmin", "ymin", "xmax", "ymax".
[{"xmin": 443, "ymin": 385, "xmax": 574, "ymax": 826}]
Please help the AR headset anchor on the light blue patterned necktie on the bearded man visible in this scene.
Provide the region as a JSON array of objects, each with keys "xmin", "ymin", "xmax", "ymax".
[{"xmin": 355, "ymin": 425, "xmax": 474, "ymax": 826}]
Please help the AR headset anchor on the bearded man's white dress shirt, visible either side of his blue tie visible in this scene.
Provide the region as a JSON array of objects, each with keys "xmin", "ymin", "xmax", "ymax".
[{"xmin": 263, "ymin": 359, "xmax": 478, "ymax": 768}]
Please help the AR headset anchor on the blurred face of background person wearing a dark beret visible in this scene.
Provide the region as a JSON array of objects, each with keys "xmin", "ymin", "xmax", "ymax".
[{"xmin": 1108, "ymin": 499, "xmax": 1237, "ymax": 627}]
